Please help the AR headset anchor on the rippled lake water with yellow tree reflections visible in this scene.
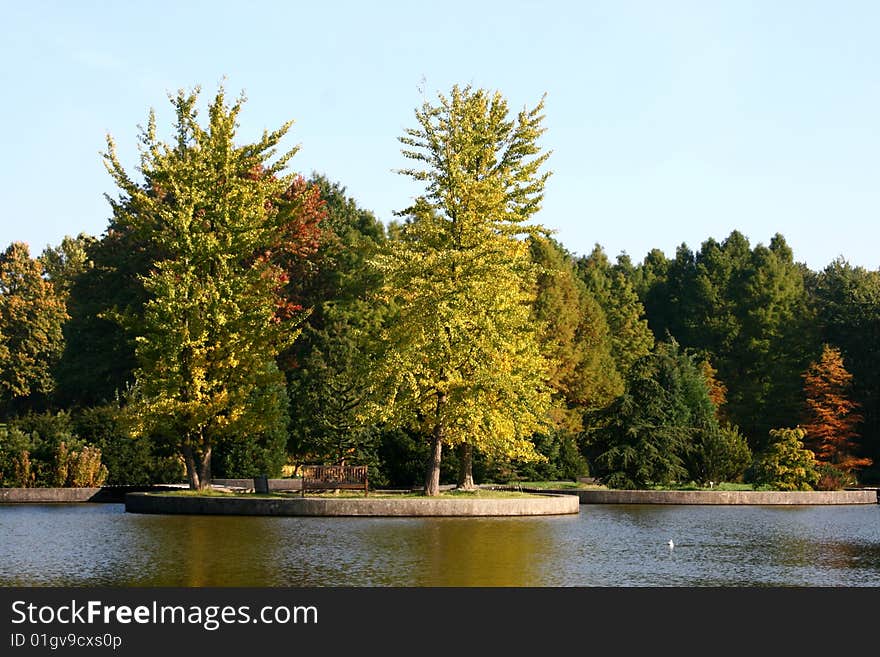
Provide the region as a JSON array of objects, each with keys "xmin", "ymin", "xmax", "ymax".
[{"xmin": 0, "ymin": 504, "xmax": 880, "ymax": 587}]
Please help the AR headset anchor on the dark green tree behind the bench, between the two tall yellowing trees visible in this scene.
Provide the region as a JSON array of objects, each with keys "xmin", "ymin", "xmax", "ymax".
[{"xmin": 283, "ymin": 176, "xmax": 385, "ymax": 468}]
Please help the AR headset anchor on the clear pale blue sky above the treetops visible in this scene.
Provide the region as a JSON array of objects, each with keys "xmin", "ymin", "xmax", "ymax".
[{"xmin": 0, "ymin": 0, "xmax": 880, "ymax": 269}]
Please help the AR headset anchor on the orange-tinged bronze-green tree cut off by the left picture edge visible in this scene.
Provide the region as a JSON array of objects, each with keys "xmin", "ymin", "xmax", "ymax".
[{"xmin": 0, "ymin": 242, "xmax": 67, "ymax": 413}]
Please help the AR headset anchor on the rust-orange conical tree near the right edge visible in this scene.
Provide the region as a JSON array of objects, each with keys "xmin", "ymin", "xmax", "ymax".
[{"xmin": 802, "ymin": 345, "xmax": 871, "ymax": 473}]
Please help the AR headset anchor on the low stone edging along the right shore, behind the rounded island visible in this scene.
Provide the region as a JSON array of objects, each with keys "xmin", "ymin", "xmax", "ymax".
[{"xmin": 528, "ymin": 489, "xmax": 880, "ymax": 505}]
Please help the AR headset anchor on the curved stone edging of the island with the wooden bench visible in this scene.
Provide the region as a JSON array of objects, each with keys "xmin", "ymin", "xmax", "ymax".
[{"xmin": 125, "ymin": 492, "xmax": 580, "ymax": 517}]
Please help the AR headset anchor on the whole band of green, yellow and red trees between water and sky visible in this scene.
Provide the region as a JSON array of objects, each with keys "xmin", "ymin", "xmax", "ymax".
[{"xmin": 0, "ymin": 87, "xmax": 880, "ymax": 494}]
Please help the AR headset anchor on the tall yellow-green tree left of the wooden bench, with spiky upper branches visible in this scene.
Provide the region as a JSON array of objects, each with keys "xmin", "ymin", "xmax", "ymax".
[{"xmin": 105, "ymin": 88, "xmax": 316, "ymax": 488}]
